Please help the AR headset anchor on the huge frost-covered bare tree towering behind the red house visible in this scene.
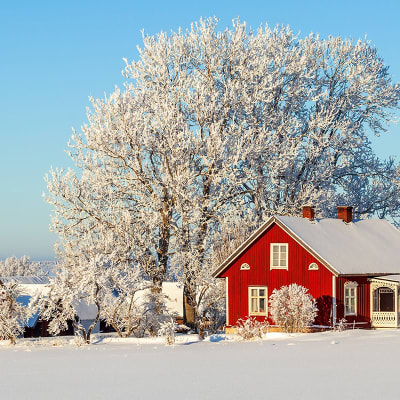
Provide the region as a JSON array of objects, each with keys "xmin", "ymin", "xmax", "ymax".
[{"xmin": 48, "ymin": 18, "xmax": 400, "ymax": 332}]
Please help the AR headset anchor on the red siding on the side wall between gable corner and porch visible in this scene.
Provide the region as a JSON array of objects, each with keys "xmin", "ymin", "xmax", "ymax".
[{"xmin": 336, "ymin": 276, "xmax": 371, "ymax": 328}]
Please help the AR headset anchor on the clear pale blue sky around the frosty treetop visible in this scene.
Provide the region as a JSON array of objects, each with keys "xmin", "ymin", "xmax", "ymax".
[{"xmin": 0, "ymin": 0, "xmax": 400, "ymax": 260}]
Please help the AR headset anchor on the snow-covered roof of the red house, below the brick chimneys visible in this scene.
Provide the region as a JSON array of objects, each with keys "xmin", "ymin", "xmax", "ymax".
[{"xmin": 214, "ymin": 216, "xmax": 400, "ymax": 276}]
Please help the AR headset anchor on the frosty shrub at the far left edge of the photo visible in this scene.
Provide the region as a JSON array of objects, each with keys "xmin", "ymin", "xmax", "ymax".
[{"xmin": 0, "ymin": 283, "xmax": 32, "ymax": 344}]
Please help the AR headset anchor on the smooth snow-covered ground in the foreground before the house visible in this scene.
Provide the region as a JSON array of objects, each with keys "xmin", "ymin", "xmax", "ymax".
[{"xmin": 0, "ymin": 330, "xmax": 400, "ymax": 400}]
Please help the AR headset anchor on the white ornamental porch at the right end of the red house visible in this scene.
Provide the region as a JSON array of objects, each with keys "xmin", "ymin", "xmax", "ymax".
[{"xmin": 370, "ymin": 277, "xmax": 400, "ymax": 328}]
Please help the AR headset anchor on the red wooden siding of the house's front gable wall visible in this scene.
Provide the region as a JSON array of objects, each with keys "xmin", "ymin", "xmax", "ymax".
[{"xmin": 221, "ymin": 224, "xmax": 339, "ymax": 325}]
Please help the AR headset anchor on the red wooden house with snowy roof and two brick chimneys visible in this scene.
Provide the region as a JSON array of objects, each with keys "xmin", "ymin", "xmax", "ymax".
[{"xmin": 214, "ymin": 207, "xmax": 400, "ymax": 327}]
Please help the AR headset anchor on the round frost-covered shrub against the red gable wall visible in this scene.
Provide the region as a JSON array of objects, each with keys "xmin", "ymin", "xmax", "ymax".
[{"xmin": 269, "ymin": 283, "xmax": 318, "ymax": 332}]
